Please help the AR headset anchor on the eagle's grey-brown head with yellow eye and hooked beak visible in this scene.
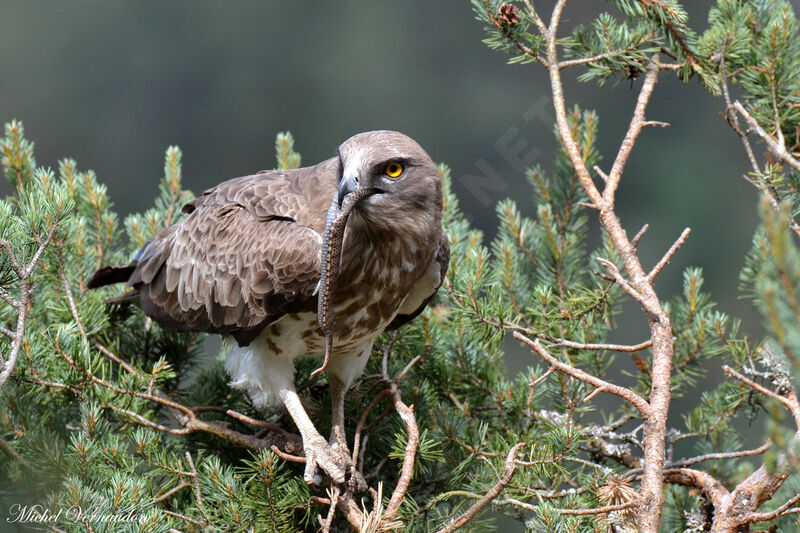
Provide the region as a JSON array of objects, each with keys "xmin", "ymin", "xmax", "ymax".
[{"xmin": 338, "ymin": 130, "xmax": 442, "ymax": 231}]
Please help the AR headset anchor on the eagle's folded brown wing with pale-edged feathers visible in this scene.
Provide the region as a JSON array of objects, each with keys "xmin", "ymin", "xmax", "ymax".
[{"xmin": 128, "ymin": 160, "xmax": 337, "ymax": 344}]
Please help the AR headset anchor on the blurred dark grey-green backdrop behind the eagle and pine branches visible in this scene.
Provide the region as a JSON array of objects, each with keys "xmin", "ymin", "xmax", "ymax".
[{"xmin": 0, "ymin": 0, "xmax": 800, "ymax": 528}]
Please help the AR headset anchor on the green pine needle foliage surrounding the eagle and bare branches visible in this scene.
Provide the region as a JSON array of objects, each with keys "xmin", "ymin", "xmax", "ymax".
[{"xmin": 0, "ymin": 0, "xmax": 800, "ymax": 532}]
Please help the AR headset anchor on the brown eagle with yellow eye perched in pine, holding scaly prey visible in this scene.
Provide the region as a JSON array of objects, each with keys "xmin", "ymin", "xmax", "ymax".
[{"xmin": 89, "ymin": 131, "xmax": 450, "ymax": 483}]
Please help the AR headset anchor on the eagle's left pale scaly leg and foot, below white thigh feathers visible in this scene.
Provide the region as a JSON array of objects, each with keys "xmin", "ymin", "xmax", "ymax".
[{"xmin": 279, "ymin": 388, "xmax": 345, "ymax": 484}]
